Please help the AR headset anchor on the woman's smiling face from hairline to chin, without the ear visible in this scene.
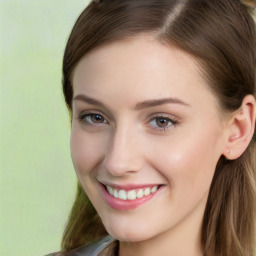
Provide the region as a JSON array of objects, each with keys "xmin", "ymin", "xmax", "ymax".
[{"xmin": 71, "ymin": 35, "xmax": 224, "ymax": 242}]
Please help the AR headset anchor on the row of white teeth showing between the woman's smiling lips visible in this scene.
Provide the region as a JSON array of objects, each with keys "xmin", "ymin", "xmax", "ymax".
[{"xmin": 104, "ymin": 185, "xmax": 161, "ymax": 201}]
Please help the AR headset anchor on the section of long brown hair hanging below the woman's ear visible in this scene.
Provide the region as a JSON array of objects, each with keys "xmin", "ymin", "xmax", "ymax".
[{"xmin": 202, "ymin": 141, "xmax": 256, "ymax": 256}]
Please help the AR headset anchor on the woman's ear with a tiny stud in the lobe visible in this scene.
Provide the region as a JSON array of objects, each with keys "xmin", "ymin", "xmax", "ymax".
[{"xmin": 223, "ymin": 95, "xmax": 256, "ymax": 160}]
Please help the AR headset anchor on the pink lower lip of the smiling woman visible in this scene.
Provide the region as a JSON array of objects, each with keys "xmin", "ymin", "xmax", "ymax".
[{"xmin": 101, "ymin": 185, "xmax": 163, "ymax": 211}]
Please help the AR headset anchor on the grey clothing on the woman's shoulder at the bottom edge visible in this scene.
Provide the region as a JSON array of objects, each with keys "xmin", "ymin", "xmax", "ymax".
[{"xmin": 45, "ymin": 236, "xmax": 115, "ymax": 256}]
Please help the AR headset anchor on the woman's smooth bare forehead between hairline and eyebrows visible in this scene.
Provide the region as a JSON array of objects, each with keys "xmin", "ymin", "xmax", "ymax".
[{"xmin": 73, "ymin": 35, "xmax": 218, "ymax": 111}]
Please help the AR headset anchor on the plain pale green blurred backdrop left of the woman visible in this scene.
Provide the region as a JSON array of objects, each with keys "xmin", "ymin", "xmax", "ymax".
[{"xmin": 0, "ymin": 0, "xmax": 88, "ymax": 256}]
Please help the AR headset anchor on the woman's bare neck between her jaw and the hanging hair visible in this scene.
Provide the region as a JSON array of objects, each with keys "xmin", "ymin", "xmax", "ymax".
[{"xmin": 119, "ymin": 196, "xmax": 204, "ymax": 256}]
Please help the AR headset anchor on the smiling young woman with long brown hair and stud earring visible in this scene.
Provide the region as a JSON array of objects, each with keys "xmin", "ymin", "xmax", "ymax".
[{"xmin": 47, "ymin": 0, "xmax": 256, "ymax": 256}]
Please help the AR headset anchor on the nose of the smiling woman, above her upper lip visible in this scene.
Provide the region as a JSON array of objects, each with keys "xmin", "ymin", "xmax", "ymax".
[{"xmin": 103, "ymin": 127, "xmax": 143, "ymax": 177}]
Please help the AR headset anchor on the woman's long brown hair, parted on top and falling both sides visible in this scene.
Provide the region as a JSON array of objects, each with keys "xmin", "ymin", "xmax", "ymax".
[{"xmin": 62, "ymin": 0, "xmax": 256, "ymax": 256}]
